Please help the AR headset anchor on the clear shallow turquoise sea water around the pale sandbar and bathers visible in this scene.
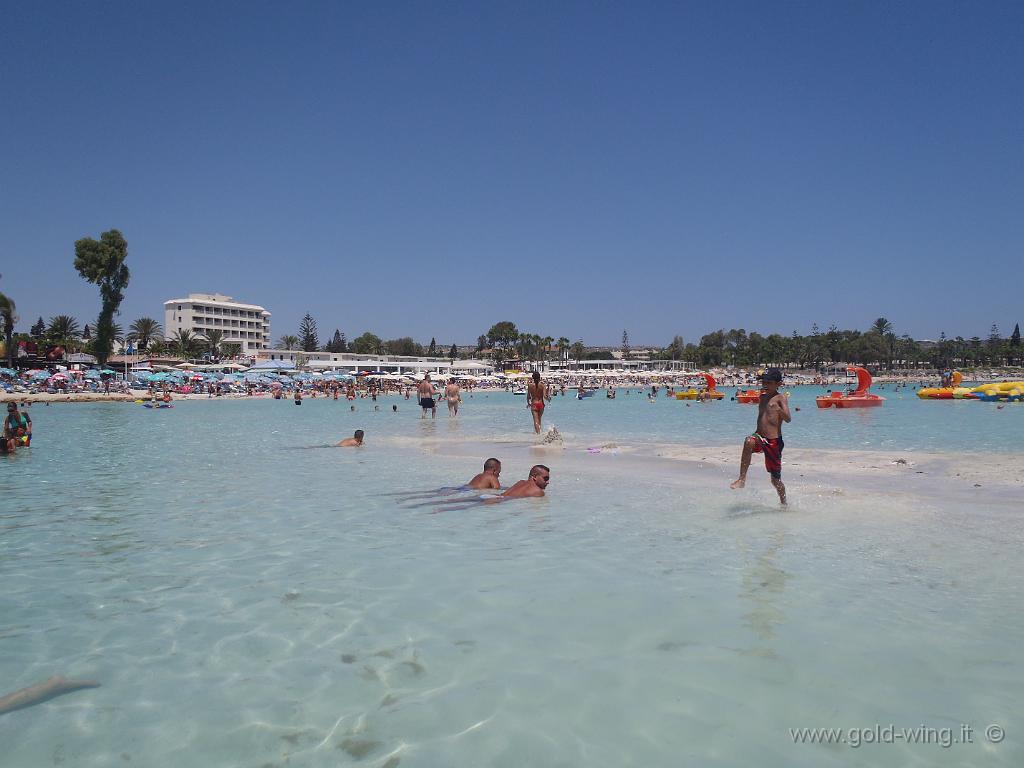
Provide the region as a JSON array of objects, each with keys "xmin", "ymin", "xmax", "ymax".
[{"xmin": 0, "ymin": 388, "xmax": 1024, "ymax": 768}]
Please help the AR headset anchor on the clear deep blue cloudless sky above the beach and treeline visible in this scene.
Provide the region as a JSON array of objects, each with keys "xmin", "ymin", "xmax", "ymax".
[{"xmin": 0, "ymin": 0, "xmax": 1024, "ymax": 345}]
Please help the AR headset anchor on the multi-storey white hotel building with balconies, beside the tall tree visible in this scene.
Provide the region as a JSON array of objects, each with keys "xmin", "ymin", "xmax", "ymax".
[{"xmin": 164, "ymin": 293, "xmax": 270, "ymax": 356}]
